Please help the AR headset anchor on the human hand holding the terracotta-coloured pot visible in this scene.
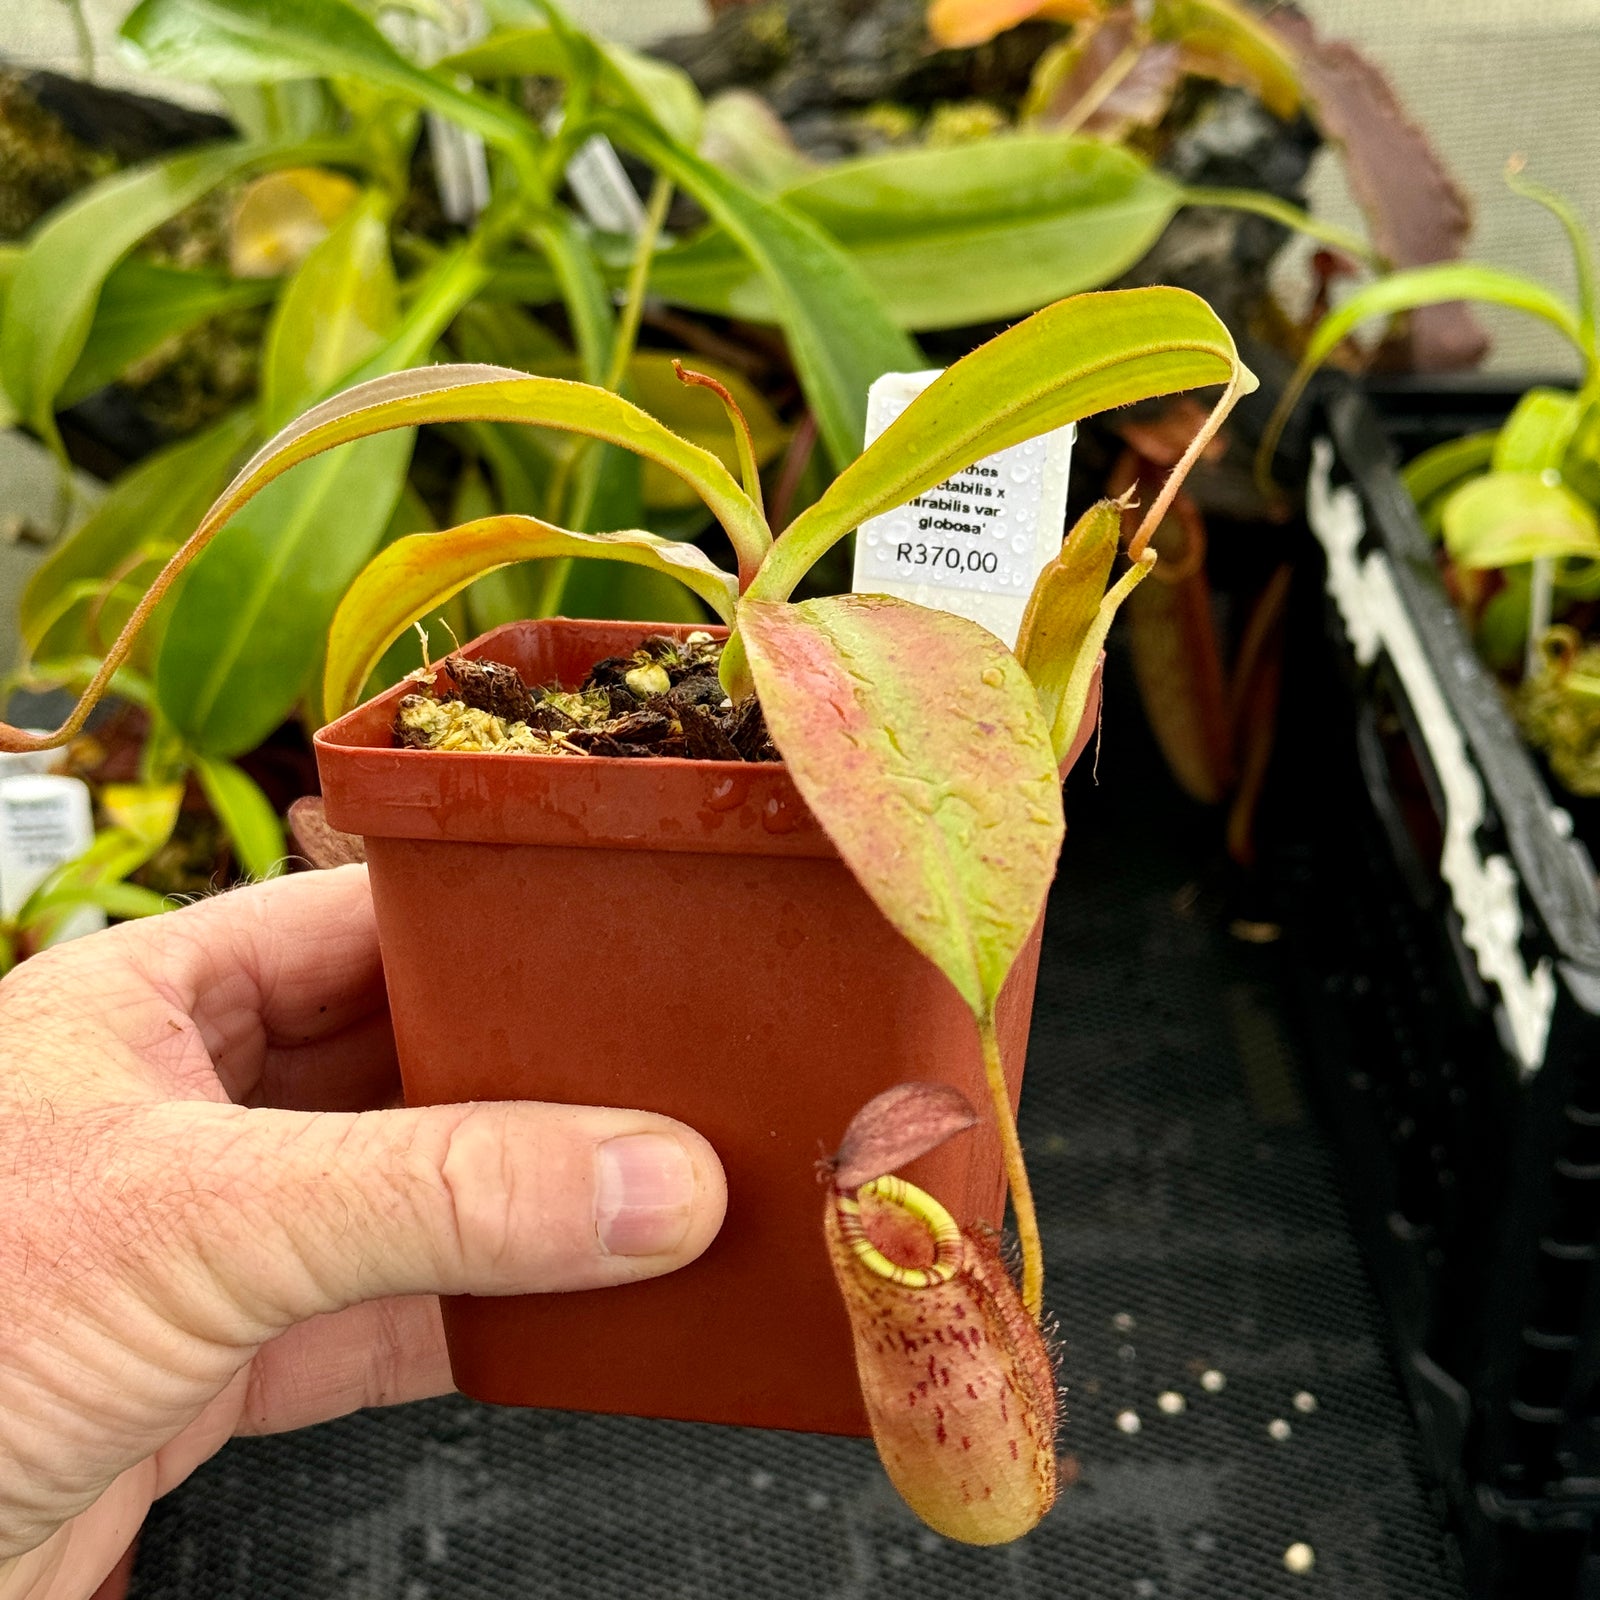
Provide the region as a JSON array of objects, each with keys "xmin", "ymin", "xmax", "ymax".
[{"xmin": 0, "ymin": 867, "xmax": 725, "ymax": 1600}]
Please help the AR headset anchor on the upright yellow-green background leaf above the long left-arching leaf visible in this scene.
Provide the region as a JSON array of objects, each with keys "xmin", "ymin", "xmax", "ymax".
[{"xmin": 261, "ymin": 190, "xmax": 400, "ymax": 434}]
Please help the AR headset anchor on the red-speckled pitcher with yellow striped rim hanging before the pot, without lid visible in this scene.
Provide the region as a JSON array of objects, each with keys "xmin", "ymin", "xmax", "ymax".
[{"xmin": 822, "ymin": 1178, "xmax": 1056, "ymax": 1544}]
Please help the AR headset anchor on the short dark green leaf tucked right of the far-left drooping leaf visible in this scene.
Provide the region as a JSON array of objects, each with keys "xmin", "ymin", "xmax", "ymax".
[{"xmin": 59, "ymin": 256, "xmax": 278, "ymax": 406}]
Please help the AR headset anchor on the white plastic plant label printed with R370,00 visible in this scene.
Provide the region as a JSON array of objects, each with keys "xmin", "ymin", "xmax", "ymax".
[{"xmin": 853, "ymin": 371, "xmax": 1077, "ymax": 645}]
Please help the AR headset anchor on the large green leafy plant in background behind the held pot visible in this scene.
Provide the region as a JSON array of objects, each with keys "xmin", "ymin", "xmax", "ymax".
[{"xmin": 0, "ymin": 0, "xmax": 1363, "ymax": 928}]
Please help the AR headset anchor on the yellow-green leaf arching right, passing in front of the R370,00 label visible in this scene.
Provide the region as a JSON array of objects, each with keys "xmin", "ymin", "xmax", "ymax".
[{"xmin": 749, "ymin": 288, "xmax": 1256, "ymax": 600}]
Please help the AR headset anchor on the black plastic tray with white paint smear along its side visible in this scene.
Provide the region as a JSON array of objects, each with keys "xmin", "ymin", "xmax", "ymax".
[{"xmin": 1275, "ymin": 382, "xmax": 1600, "ymax": 1600}]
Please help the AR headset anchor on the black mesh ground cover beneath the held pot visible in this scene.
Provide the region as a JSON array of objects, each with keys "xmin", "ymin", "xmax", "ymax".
[{"xmin": 133, "ymin": 665, "xmax": 1461, "ymax": 1600}]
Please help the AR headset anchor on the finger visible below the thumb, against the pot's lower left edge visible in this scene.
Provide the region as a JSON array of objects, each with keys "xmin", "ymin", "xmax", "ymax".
[{"xmin": 238, "ymin": 1294, "xmax": 454, "ymax": 1434}]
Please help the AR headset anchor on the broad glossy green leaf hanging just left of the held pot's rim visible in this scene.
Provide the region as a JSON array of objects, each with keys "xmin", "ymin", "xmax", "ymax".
[{"xmin": 155, "ymin": 430, "xmax": 413, "ymax": 757}]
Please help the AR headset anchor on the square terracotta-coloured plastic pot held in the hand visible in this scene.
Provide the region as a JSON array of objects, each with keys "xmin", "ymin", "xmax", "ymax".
[{"xmin": 317, "ymin": 619, "xmax": 1038, "ymax": 1434}]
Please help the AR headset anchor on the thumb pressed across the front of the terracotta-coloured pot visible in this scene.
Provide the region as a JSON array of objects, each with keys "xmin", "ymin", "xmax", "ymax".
[{"xmin": 148, "ymin": 1102, "xmax": 726, "ymax": 1342}]
